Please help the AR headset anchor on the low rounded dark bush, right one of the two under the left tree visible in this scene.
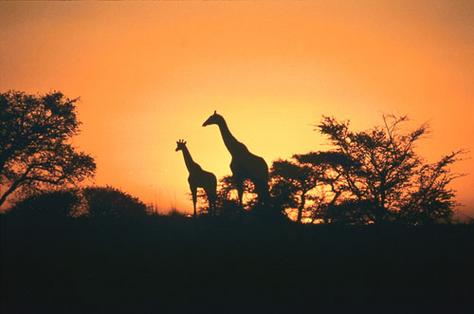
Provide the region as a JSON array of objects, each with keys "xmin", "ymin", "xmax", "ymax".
[{"xmin": 82, "ymin": 186, "xmax": 147, "ymax": 218}]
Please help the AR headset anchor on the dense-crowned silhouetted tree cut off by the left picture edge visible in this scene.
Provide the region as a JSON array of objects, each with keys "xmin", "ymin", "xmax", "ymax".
[{"xmin": 0, "ymin": 91, "xmax": 96, "ymax": 205}]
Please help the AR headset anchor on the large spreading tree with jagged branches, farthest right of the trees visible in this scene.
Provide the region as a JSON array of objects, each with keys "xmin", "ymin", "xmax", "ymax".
[{"xmin": 318, "ymin": 116, "xmax": 462, "ymax": 223}]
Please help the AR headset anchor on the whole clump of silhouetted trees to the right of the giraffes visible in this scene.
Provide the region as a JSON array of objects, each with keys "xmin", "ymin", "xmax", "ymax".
[{"xmin": 272, "ymin": 116, "xmax": 463, "ymax": 224}]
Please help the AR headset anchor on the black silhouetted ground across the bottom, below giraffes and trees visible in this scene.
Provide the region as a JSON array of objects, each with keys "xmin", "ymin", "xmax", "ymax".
[{"xmin": 0, "ymin": 214, "xmax": 474, "ymax": 313}]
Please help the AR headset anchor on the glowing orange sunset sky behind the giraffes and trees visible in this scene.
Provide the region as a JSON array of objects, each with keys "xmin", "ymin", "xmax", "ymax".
[{"xmin": 0, "ymin": 0, "xmax": 474, "ymax": 214}]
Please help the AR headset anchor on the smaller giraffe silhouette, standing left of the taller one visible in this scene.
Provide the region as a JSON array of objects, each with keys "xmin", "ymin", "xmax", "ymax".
[{"xmin": 175, "ymin": 140, "xmax": 217, "ymax": 218}]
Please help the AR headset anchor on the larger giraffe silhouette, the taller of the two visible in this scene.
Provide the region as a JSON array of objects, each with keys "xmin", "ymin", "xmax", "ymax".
[{"xmin": 202, "ymin": 111, "xmax": 269, "ymax": 205}]
